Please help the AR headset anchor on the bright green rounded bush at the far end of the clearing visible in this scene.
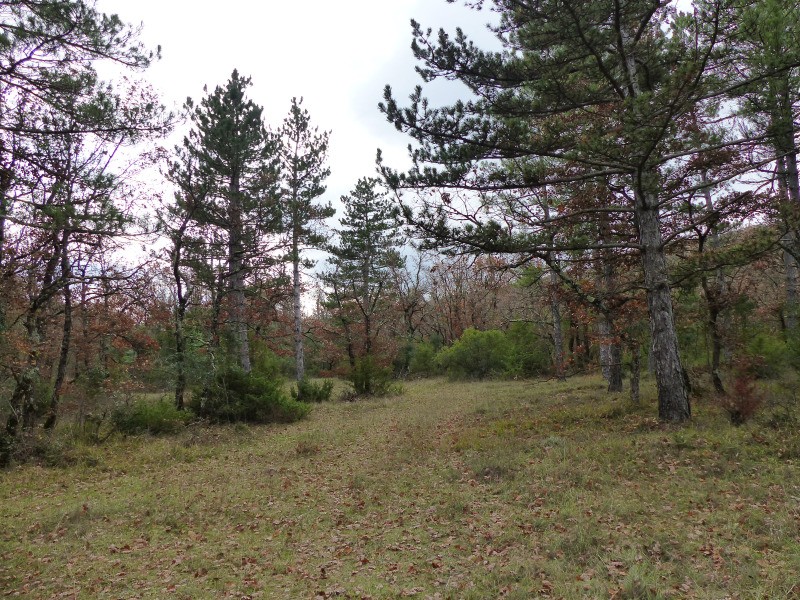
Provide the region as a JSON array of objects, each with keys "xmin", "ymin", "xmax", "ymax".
[{"xmin": 437, "ymin": 329, "xmax": 513, "ymax": 379}]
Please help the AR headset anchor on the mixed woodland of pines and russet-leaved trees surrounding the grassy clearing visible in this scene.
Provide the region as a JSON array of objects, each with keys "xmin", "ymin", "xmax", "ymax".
[{"xmin": 0, "ymin": 0, "xmax": 800, "ymax": 454}]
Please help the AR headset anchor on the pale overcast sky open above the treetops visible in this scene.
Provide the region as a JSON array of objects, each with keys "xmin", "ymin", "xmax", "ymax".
[{"xmin": 92, "ymin": 0, "xmax": 493, "ymax": 201}]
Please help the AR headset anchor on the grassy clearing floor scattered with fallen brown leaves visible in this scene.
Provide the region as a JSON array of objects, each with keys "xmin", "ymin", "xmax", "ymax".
[{"xmin": 0, "ymin": 377, "xmax": 800, "ymax": 600}]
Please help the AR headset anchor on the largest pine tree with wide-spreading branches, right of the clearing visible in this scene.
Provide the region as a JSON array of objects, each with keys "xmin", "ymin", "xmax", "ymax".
[{"xmin": 381, "ymin": 0, "xmax": 768, "ymax": 421}]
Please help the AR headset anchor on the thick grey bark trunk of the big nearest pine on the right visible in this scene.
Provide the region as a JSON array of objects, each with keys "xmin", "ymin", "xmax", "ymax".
[{"xmin": 634, "ymin": 172, "xmax": 691, "ymax": 423}]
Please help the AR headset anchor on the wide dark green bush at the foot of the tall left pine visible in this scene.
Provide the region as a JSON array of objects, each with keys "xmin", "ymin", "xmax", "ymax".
[{"xmin": 189, "ymin": 368, "xmax": 310, "ymax": 423}]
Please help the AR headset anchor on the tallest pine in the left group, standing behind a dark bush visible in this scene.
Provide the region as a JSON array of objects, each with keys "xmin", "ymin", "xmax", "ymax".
[{"xmin": 171, "ymin": 70, "xmax": 279, "ymax": 373}]
